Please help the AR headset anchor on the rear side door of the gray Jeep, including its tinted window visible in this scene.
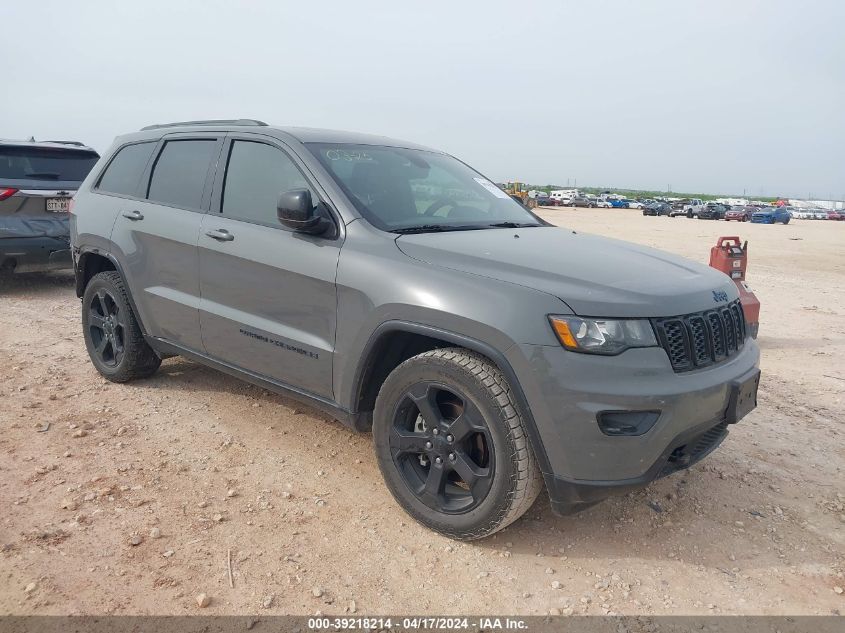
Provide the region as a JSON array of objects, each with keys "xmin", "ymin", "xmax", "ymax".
[{"xmin": 112, "ymin": 133, "xmax": 225, "ymax": 351}]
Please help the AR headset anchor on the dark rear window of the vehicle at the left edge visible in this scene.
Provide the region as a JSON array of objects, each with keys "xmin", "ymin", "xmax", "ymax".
[{"xmin": 0, "ymin": 146, "xmax": 99, "ymax": 182}]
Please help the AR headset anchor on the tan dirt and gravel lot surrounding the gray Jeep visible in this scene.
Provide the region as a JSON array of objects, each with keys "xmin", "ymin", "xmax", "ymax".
[{"xmin": 0, "ymin": 209, "xmax": 845, "ymax": 614}]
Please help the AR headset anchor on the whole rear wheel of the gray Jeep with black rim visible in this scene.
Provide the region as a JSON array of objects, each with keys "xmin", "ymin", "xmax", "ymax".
[{"xmin": 82, "ymin": 270, "xmax": 161, "ymax": 382}]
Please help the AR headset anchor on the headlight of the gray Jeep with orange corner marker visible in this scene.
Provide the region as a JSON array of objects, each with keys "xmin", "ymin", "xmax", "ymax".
[{"xmin": 549, "ymin": 316, "xmax": 657, "ymax": 355}]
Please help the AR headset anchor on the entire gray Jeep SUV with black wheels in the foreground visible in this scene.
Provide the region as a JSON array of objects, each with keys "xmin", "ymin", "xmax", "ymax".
[{"xmin": 71, "ymin": 120, "xmax": 759, "ymax": 539}]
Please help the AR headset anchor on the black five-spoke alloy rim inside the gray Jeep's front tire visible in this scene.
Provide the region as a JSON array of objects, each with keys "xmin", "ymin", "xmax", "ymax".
[{"xmin": 390, "ymin": 381, "xmax": 494, "ymax": 514}]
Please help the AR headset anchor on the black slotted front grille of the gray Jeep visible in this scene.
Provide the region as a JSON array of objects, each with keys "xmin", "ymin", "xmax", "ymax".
[{"xmin": 652, "ymin": 301, "xmax": 746, "ymax": 371}]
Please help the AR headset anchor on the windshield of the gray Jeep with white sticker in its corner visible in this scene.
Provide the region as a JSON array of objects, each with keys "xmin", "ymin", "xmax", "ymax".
[{"xmin": 308, "ymin": 143, "xmax": 543, "ymax": 231}]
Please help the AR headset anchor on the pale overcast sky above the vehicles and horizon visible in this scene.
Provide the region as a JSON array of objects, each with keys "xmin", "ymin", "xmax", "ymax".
[{"xmin": 0, "ymin": 0, "xmax": 845, "ymax": 198}]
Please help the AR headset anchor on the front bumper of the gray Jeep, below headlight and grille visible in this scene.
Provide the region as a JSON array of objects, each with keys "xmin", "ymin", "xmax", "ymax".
[{"xmin": 508, "ymin": 338, "xmax": 759, "ymax": 513}]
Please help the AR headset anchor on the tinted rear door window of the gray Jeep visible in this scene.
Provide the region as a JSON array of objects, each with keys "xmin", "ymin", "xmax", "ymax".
[{"xmin": 147, "ymin": 139, "xmax": 217, "ymax": 209}]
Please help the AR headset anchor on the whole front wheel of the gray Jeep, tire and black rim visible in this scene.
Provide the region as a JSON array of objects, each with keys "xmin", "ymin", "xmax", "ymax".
[{"xmin": 373, "ymin": 347, "xmax": 542, "ymax": 540}]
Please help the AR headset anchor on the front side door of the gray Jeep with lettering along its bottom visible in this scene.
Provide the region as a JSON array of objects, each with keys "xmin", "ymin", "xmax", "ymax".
[{"xmin": 199, "ymin": 134, "xmax": 340, "ymax": 398}]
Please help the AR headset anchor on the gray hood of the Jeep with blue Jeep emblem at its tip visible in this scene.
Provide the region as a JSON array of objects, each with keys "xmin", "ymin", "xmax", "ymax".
[{"xmin": 396, "ymin": 227, "xmax": 738, "ymax": 317}]
